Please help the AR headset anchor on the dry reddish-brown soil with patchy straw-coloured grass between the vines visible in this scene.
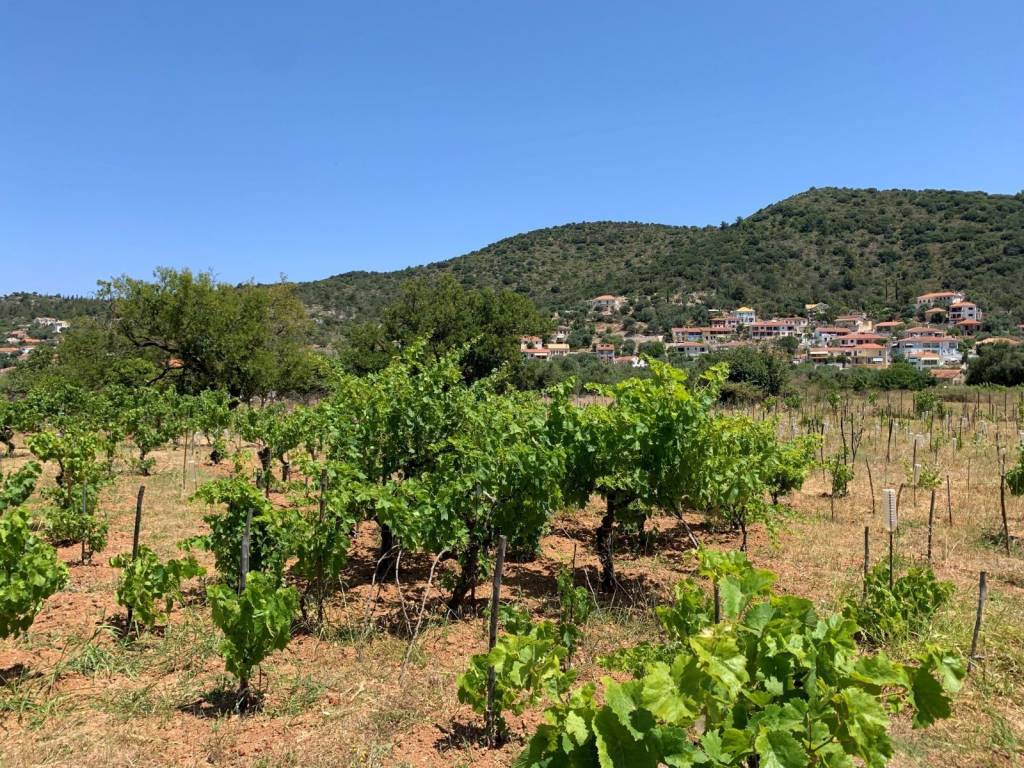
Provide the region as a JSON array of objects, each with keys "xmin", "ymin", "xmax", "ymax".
[{"xmin": 0, "ymin": 402, "xmax": 1024, "ymax": 768}]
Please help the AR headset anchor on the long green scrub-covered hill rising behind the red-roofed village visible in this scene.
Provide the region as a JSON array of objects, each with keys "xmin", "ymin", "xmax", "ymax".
[{"xmin": 299, "ymin": 188, "xmax": 1024, "ymax": 322}]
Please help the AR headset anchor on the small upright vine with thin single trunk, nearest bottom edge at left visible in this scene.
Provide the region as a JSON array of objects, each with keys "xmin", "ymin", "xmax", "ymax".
[{"xmin": 207, "ymin": 572, "xmax": 299, "ymax": 688}]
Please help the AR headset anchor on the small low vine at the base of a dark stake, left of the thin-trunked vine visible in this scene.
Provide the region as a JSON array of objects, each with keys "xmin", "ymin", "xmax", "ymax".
[{"xmin": 111, "ymin": 546, "xmax": 206, "ymax": 627}]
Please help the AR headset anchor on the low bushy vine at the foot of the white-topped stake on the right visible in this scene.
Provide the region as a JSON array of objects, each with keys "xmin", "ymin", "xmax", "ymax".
[{"xmin": 844, "ymin": 563, "xmax": 954, "ymax": 645}]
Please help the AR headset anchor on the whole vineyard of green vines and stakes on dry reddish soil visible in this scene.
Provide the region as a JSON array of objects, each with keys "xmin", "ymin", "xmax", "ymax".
[{"xmin": 0, "ymin": 344, "xmax": 1024, "ymax": 768}]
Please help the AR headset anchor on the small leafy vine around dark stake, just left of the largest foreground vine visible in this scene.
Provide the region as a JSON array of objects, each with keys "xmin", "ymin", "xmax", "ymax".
[{"xmin": 458, "ymin": 612, "xmax": 575, "ymax": 737}]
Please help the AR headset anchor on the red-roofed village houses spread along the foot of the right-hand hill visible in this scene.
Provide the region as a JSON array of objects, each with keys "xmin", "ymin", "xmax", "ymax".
[{"xmin": 520, "ymin": 291, "xmax": 1024, "ymax": 383}]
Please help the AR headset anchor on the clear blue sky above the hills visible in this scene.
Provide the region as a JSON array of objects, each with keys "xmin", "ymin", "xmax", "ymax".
[{"xmin": 0, "ymin": 0, "xmax": 1024, "ymax": 293}]
